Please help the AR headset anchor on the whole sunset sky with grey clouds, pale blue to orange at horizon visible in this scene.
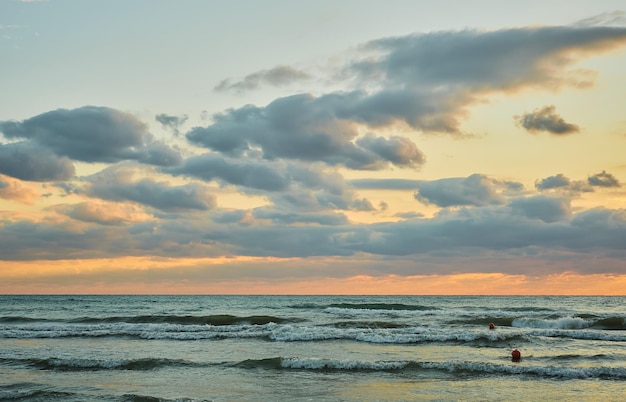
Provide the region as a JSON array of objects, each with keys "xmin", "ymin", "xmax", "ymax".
[{"xmin": 0, "ymin": 0, "xmax": 626, "ymax": 295}]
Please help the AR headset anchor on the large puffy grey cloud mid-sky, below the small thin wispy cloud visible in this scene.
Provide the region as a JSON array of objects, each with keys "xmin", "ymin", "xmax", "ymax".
[{"xmin": 187, "ymin": 92, "xmax": 424, "ymax": 169}]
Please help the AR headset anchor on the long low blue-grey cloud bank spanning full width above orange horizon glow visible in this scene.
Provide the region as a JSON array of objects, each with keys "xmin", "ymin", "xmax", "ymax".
[{"xmin": 0, "ymin": 197, "xmax": 626, "ymax": 266}]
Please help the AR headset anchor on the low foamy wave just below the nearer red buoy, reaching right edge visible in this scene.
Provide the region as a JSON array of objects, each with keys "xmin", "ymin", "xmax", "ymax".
[{"xmin": 234, "ymin": 357, "xmax": 626, "ymax": 380}]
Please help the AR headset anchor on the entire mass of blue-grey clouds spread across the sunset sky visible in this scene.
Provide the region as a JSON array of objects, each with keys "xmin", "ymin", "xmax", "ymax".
[{"xmin": 0, "ymin": 23, "xmax": 626, "ymax": 288}]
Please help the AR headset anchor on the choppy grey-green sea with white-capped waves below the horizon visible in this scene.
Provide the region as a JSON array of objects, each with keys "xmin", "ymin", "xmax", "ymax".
[{"xmin": 0, "ymin": 295, "xmax": 626, "ymax": 401}]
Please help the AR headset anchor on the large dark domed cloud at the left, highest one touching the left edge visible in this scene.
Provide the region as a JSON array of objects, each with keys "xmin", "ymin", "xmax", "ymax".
[{"xmin": 0, "ymin": 106, "xmax": 181, "ymax": 176}]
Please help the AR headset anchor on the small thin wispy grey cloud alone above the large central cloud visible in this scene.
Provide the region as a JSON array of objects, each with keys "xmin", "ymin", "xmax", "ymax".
[{"xmin": 214, "ymin": 66, "xmax": 310, "ymax": 92}]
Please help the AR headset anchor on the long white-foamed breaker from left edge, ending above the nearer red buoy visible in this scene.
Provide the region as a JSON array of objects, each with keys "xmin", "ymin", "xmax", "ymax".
[{"xmin": 0, "ymin": 321, "xmax": 523, "ymax": 344}]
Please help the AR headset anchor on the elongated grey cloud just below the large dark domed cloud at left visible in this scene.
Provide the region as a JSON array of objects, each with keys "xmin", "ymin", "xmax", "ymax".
[{"xmin": 85, "ymin": 168, "xmax": 216, "ymax": 212}]
